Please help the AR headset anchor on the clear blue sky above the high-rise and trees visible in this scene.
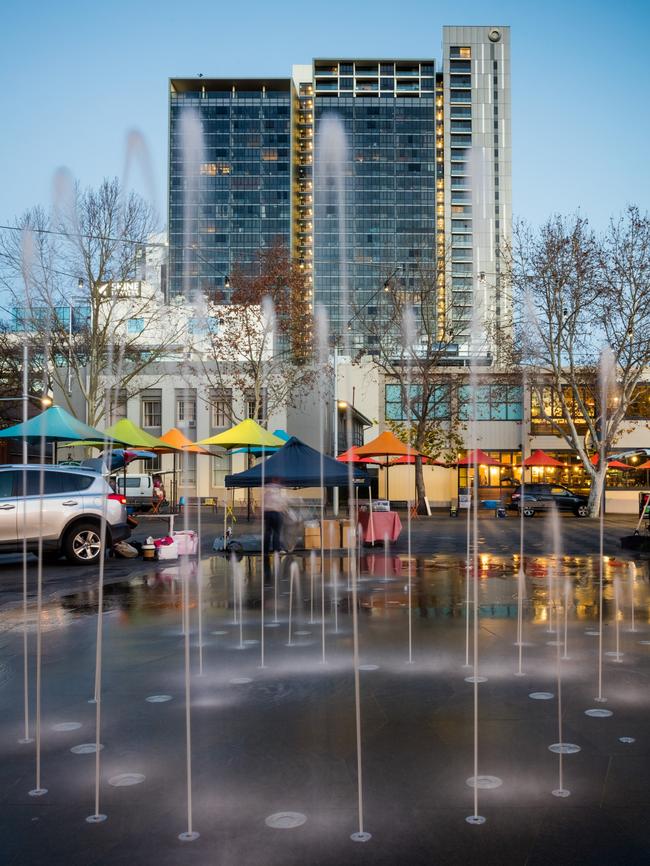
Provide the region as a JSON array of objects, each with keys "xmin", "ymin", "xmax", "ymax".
[{"xmin": 0, "ymin": 0, "xmax": 650, "ymax": 226}]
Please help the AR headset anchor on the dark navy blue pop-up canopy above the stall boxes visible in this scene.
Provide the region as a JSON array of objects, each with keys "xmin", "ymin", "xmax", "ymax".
[{"xmin": 226, "ymin": 436, "xmax": 369, "ymax": 487}]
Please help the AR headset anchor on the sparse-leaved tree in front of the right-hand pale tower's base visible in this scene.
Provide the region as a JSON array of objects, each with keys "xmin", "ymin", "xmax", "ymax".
[{"xmin": 354, "ymin": 263, "xmax": 464, "ymax": 513}]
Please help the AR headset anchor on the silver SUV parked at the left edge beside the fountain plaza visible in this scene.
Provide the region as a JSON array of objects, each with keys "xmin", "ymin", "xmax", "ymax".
[{"xmin": 0, "ymin": 463, "xmax": 131, "ymax": 565}]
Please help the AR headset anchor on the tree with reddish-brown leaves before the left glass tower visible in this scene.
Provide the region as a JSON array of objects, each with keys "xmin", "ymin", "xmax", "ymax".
[{"xmin": 200, "ymin": 244, "xmax": 315, "ymax": 424}]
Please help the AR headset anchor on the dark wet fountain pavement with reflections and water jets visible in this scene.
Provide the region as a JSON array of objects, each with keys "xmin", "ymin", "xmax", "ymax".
[{"xmin": 0, "ymin": 544, "xmax": 650, "ymax": 866}]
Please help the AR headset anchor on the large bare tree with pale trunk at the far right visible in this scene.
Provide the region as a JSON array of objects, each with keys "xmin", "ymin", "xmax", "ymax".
[{"xmin": 510, "ymin": 207, "xmax": 650, "ymax": 515}]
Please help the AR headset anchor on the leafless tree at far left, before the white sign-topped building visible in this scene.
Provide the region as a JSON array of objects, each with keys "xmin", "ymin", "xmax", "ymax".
[{"xmin": 0, "ymin": 179, "xmax": 183, "ymax": 426}]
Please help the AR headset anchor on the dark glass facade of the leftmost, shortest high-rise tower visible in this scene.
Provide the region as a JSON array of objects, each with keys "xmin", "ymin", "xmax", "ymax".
[{"xmin": 169, "ymin": 79, "xmax": 291, "ymax": 301}]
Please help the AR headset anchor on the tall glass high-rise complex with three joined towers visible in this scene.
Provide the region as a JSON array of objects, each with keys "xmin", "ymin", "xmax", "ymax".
[{"xmin": 169, "ymin": 26, "xmax": 512, "ymax": 355}]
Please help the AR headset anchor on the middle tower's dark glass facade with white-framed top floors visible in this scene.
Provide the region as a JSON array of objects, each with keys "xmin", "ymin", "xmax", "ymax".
[{"xmin": 314, "ymin": 60, "xmax": 436, "ymax": 349}]
